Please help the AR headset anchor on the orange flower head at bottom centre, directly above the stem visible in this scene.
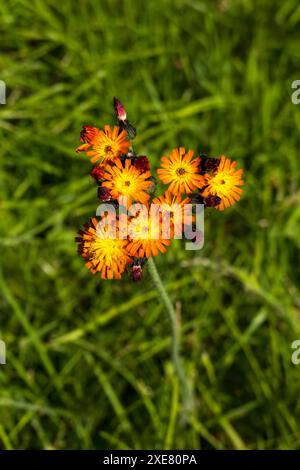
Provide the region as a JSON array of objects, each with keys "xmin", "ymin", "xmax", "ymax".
[{"xmin": 127, "ymin": 205, "xmax": 171, "ymax": 258}]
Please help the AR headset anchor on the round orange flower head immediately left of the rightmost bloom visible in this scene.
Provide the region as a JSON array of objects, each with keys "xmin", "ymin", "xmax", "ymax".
[{"xmin": 157, "ymin": 147, "xmax": 205, "ymax": 194}]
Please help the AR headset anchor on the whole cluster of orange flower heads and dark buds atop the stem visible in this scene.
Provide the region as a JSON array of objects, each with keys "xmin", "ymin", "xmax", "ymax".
[{"xmin": 76, "ymin": 98, "xmax": 243, "ymax": 281}]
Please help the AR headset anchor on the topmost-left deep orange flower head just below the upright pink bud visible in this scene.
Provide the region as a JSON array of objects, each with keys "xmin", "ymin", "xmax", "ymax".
[{"xmin": 76, "ymin": 126, "xmax": 131, "ymax": 163}]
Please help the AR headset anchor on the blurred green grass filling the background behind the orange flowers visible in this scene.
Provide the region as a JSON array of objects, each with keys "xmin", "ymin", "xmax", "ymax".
[{"xmin": 0, "ymin": 0, "xmax": 300, "ymax": 449}]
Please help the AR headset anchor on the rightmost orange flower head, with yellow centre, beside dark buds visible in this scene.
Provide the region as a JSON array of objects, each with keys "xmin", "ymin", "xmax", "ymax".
[{"xmin": 201, "ymin": 155, "xmax": 244, "ymax": 211}]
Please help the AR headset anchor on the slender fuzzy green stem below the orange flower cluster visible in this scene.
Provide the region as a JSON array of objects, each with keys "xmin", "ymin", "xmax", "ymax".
[{"xmin": 147, "ymin": 257, "xmax": 193, "ymax": 412}]
